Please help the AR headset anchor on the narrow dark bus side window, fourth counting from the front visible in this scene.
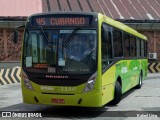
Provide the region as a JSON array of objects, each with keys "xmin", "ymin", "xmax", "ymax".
[{"xmin": 130, "ymin": 36, "xmax": 136, "ymax": 57}]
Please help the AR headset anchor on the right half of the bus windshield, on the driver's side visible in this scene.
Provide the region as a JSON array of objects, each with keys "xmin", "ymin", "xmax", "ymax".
[{"xmin": 58, "ymin": 30, "xmax": 97, "ymax": 74}]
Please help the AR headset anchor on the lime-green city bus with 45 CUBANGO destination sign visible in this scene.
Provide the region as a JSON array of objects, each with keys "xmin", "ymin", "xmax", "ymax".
[{"xmin": 14, "ymin": 11, "xmax": 148, "ymax": 107}]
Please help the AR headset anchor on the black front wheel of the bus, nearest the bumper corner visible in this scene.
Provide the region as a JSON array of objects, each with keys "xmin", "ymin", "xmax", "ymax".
[{"xmin": 110, "ymin": 81, "xmax": 122, "ymax": 105}]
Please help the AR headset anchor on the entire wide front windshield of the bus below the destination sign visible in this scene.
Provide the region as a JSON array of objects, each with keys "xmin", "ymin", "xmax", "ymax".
[{"xmin": 23, "ymin": 29, "xmax": 97, "ymax": 74}]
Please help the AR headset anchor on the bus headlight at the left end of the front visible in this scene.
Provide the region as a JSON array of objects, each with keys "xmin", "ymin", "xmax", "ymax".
[{"xmin": 21, "ymin": 71, "xmax": 34, "ymax": 90}]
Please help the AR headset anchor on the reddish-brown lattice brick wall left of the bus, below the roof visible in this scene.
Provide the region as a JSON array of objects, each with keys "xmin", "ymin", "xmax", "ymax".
[{"xmin": 0, "ymin": 28, "xmax": 23, "ymax": 61}]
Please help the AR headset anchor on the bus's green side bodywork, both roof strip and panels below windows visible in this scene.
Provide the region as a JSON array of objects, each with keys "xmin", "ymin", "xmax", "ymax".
[{"xmin": 99, "ymin": 12, "xmax": 147, "ymax": 105}]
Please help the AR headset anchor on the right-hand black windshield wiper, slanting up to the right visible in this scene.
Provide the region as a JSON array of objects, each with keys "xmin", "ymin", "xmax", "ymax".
[{"xmin": 62, "ymin": 27, "xmax": 80, "ymax": 48}]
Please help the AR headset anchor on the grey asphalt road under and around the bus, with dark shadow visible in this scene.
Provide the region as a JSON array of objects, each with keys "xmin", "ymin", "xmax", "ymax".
[{"xmin": 0, "ymin": 76, "xmax": 160, "ymax": 120}]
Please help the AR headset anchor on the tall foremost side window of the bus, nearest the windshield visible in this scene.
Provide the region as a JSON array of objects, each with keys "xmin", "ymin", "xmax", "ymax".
[{"xmin": 101, "ymin": 24, "xmax": 113, "ymax": 70}]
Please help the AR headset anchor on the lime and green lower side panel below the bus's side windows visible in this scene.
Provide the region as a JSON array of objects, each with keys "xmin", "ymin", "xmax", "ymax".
[{"xmin": 102, "ymin": 59, "xmax": 147, "ymax": 105}]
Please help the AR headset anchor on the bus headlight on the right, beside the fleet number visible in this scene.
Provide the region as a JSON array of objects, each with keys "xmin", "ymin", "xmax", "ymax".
[{"xmin": 83, "ymin": 78, "xmax": 96, "ymax": 92}]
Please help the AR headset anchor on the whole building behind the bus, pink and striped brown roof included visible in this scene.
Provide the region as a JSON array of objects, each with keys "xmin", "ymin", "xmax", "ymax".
[{"xmin": 0, "ymin": 0, "xmax": 160, "ymax": 72}]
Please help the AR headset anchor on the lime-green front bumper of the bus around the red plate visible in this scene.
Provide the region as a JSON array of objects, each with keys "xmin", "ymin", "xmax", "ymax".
[{"xmin": 22, "ymin": 87, "xmax": 102, "ymax": 107}]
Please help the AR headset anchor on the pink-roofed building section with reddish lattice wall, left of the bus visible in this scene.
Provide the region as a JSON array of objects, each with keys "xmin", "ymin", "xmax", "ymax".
[{"xmin": 0, "ymin": 0, "xmax": 42, "ymax": 61}]
